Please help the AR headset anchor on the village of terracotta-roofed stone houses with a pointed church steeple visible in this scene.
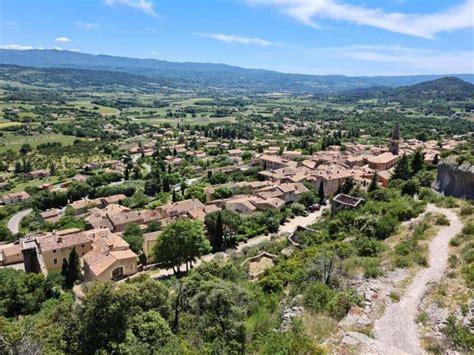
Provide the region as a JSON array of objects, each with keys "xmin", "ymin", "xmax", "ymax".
[{"xmin": 0, "ymin": 122, "xmax": 460, "ymax": 282}]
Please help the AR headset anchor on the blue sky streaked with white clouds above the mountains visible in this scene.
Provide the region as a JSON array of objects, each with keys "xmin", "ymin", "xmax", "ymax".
[{"xmin": 0, "ymin": 0, "xmax": 474, "ymax": 75}]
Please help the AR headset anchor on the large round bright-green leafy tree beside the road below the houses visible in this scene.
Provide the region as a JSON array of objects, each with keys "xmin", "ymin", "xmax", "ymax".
[{"xmin": 153, "ymin": 219, "xmax": 210, "ymax": 273}]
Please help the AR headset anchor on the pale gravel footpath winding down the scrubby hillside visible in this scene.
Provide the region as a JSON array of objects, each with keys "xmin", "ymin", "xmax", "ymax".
[{"xmin": 374, "ymin": 205, "xmax": 463, "ymax": 354}]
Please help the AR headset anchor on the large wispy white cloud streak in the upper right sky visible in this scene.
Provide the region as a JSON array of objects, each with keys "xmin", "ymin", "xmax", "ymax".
[{"xmin": 246, "ymin": 0, "xmax": 474, "ymax": 39}]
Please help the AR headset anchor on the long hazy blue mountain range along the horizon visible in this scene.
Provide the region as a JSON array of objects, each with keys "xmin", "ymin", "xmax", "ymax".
[{"xmin": 0, "ymin": 49, "xmax": 474, "ymax": 94}]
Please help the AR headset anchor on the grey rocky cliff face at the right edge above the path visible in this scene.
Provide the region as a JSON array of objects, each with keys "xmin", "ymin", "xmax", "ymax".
[{"xmin": 434, "ymin": 156, "xmax": 474, "ymax": 199}]
